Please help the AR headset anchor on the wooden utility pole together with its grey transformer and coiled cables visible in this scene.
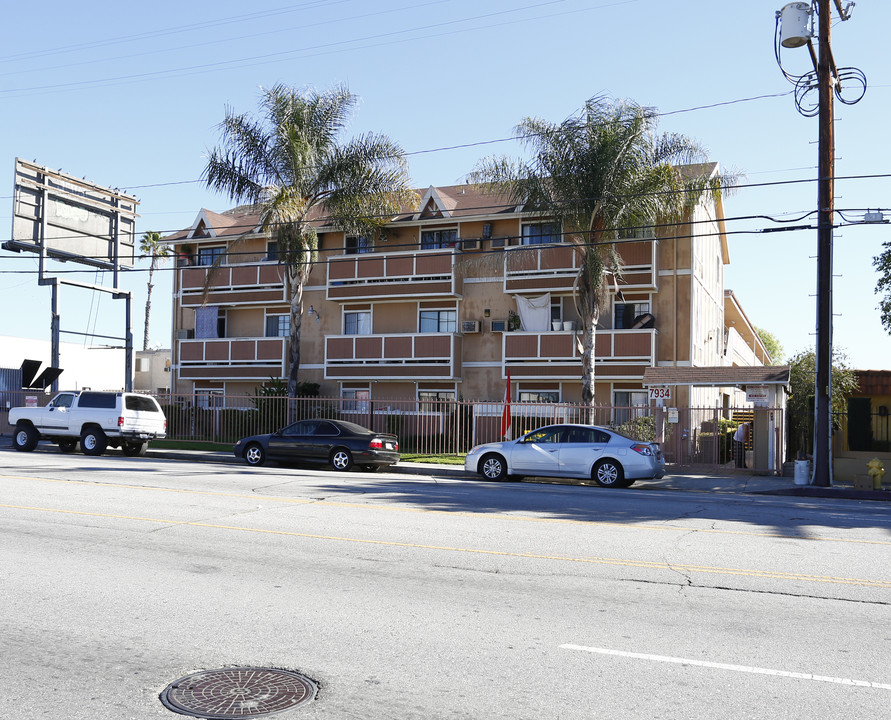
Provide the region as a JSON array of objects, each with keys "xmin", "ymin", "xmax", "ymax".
[{"xmin": 775, "ymin": 0, "xmax": 866, "ymax": 487}]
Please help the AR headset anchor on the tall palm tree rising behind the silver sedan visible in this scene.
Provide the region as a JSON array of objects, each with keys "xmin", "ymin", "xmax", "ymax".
[{"xmin": 470, "ymin": 96, "xmax": 735, "ymax": 404}]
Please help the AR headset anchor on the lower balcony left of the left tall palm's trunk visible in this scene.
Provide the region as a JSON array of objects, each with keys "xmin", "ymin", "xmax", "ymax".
[{"xmin": 178, "ymin": 337, "xmax": 288, "ymax": 380}]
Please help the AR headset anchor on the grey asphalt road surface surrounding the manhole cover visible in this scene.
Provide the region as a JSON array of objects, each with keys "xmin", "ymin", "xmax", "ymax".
[{"xmin": 0, "ymin": 450, "xmax": 891, "ymax": 720}]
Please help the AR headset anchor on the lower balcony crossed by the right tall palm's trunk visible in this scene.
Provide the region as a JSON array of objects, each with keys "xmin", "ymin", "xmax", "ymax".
[{"xmin": 501, "ymin": 328, "xmax": 657, "ymax": 379}]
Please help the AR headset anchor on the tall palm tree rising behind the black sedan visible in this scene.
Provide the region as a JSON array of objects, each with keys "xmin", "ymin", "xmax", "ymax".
[{"xmin": 204, "ymin": 85, "xmax": 417, "ymax": 397}]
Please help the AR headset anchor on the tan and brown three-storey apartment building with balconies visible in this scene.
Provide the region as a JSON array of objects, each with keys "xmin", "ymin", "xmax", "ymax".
[{"xmin": 165, "ymin": 172, "xmax": 768, "ymax": 407}]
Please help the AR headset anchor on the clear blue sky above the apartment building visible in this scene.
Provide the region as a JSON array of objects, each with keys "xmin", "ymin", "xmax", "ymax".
[{"xmin": 0, "ymin": 0, "xmax": 891, "ymax": 369}]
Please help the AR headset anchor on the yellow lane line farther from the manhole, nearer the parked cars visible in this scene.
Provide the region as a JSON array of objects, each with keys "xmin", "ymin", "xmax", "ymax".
[{"xmin": 0, "ymin": 475, "xmax": 891, "ymax": 546}]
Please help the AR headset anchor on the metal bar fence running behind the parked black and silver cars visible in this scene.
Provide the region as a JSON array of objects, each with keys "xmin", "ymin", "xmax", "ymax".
[{"xmin": 0, "ymin": 391, "xmax": 783, "ymax": 470}]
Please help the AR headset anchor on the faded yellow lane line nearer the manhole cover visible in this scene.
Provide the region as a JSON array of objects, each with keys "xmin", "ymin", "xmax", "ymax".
[{"xmin": 0, "ymin": 503, "xmax": 891, "ymax": 589}]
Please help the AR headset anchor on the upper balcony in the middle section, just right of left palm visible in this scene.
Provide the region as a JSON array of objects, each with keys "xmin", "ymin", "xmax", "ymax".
[{"xmin": 327, "ymin": 250, "xmax": 461, "ymax": 301}]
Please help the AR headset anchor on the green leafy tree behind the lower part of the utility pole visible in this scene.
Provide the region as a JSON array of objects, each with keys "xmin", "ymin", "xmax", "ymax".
[{"xmin": 786, "ymin": 348, "xmax": 859, "ymax": 457}]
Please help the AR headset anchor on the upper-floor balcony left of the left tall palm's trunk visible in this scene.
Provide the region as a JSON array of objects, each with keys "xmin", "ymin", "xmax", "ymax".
[{"xmin": 178, "ymin": 262, "xmax": 288, "ymax": 307}]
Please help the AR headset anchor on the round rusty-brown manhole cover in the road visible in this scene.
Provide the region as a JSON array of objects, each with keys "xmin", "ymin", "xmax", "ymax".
[{"xmin": 161, "ymin": 668, "xmax": 316, "ymax": 720}]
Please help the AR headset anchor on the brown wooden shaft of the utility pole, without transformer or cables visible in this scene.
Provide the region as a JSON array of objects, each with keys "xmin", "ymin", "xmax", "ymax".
[{"xmin": 812, "ymin": 0, "xmax": 837, "ymax": 487}]
